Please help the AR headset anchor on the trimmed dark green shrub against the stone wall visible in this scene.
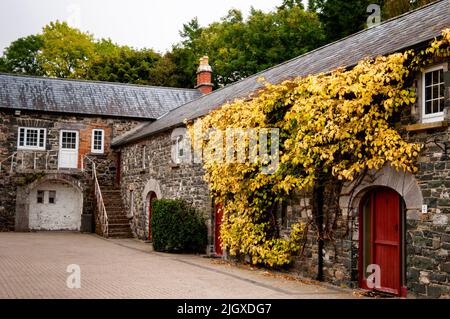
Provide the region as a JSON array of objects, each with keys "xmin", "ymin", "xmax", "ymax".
[{"xmin": 152, "ymin": 199, "xmax": 208, "ymax": 253}]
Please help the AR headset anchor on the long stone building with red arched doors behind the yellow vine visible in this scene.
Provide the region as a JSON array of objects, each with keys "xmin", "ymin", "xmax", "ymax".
[{"xmin": 112, "ymin": 0, "xmax": 450, "ymax": 297}]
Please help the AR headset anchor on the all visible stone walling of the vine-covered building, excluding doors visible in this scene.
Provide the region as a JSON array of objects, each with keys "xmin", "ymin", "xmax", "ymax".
[{"xmin": 117, "ymin": 61, "xmax": 450, "ymax": 298}]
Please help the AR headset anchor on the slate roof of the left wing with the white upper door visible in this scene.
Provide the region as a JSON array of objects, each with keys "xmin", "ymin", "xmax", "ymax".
[{"xmin": 0, "ymin": 73, "xmax": 201, "ymax": 120}]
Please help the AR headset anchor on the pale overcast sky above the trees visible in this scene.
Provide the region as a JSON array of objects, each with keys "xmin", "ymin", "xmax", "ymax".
[{"xmin": 0, "ymin": 0, "xmax": 288, "ymax": 55}]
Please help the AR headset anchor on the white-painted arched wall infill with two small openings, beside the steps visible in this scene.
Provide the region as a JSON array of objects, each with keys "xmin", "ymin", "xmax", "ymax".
[{"xmin": 29, "ymin": 181, "xmax": 83, "ymax": 231}]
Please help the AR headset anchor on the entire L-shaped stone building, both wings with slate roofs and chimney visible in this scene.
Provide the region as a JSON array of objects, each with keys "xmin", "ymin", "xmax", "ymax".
[{"xmin": 0, "ymin": 0, "xmax": 450, "ymax": 297}]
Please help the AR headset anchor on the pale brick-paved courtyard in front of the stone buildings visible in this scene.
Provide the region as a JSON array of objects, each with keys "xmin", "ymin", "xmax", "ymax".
[{"xmin": 0, "ymin": 233, "xmax": 354, "ymax": 299}]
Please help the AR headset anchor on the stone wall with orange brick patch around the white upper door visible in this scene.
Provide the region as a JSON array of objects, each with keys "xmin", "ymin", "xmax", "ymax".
[{"xmin": 0, "ymin": 109, "xmax": 144, "ymax": 231}]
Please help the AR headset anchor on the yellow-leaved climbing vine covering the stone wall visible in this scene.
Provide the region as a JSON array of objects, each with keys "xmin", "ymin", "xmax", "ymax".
[{"xmin": 189, "ymin": 29, "xmax": 450, "ymax": 266}]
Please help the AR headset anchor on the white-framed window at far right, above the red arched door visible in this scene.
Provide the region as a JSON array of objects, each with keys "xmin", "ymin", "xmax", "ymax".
[{"xmin": 422, "ymin": 66, "xmax": 445, "ymax": 123}]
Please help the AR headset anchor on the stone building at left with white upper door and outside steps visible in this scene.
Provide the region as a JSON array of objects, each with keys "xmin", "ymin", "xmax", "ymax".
[{"xmin": 0, "ymin": 74, "xmax": 201, "ymax": 237}]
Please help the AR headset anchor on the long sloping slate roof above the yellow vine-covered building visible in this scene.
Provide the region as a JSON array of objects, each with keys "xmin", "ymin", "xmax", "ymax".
[{"xmin": 113, "ymin": 0, "xmax": 450, "ymax": 146}]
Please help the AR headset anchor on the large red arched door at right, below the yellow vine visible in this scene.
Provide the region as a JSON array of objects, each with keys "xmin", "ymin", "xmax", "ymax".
[{"xmin": 359, "ymin": 188, "xmax": 406, "ymax": 296}]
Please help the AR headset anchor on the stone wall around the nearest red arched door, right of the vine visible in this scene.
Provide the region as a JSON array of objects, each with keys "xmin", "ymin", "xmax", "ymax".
[{"xmin": 283, "ymin": 61, "xmax": 450, "ymax": 298}]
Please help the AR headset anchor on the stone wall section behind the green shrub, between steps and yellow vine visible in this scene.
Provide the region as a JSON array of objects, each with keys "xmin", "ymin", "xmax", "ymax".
[{"xmin": 121, "ymin": 132, "xmax": 212, "ymax": 251}]
